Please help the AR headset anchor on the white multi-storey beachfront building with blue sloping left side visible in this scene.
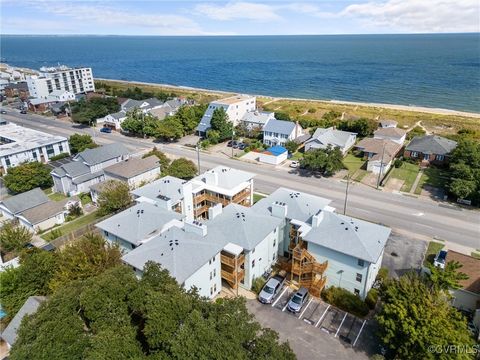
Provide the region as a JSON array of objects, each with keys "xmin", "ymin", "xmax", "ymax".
[{"xmin": 197, "ymin": 94, "xmax": 257, "ymax": 135}]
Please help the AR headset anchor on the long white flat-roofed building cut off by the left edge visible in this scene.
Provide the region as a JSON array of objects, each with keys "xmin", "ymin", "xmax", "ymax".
[{"xmin": 0, "ymin": 123, "xmax": 70, "ymax": 174}]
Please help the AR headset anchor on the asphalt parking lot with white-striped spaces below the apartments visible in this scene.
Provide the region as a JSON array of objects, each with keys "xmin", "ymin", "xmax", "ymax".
[{"xmin": 249, "ymin": 286, "xmax": 376, "ymax": 359}]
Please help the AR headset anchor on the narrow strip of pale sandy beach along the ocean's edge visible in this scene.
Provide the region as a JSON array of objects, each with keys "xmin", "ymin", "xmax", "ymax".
[{"xmin": 95, "ymin": 78, "xmax": 480, "ymax": 119}]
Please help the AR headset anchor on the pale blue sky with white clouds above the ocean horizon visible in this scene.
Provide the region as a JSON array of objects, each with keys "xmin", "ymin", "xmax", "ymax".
[{"xmin": 0, "ymin": 0, "xmax": 480, "ymax": 35}]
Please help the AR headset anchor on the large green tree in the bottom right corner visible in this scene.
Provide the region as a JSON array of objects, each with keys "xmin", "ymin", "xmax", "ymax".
[{"xmin": 377, "ymin": 272, "xmax": 472, "ymax": 359}]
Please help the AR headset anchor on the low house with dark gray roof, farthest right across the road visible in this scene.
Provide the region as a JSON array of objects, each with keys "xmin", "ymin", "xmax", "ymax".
[{"xmin": 403, "ymin": 135, "xmax": 457, "ymax": 165}]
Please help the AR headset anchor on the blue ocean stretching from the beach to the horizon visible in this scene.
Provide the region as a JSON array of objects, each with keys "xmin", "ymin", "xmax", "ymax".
[{"xmin": 0, "ymin": 33, "xmax": 480, "ymax": 112}]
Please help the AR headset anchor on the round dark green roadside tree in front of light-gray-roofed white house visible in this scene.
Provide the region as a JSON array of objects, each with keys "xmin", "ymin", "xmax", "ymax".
[{"xmin": 300, "ymin": 146, "xmax": 343, "ymax": 176}]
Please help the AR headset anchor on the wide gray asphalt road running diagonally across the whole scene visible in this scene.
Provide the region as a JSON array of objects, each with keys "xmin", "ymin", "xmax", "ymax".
[{"xmin": 2, "ymin": 110, "xmax": 480, "ymax": 249}]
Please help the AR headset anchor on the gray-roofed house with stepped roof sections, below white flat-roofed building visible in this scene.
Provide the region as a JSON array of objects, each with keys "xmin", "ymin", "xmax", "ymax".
[{"xmin": 50, "ymin": 143, "xmax": 129, "ymax": 195}]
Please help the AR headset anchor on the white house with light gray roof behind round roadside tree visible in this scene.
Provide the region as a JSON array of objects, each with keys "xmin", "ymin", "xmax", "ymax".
[{"xmin": 305, "ymin": 127, "xmax": 357, "ymax": 155}]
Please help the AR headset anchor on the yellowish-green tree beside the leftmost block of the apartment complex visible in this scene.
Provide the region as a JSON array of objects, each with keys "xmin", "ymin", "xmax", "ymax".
[{"xmin": 50, "ymin": 233, "xmax": 122, "ymax": 290}]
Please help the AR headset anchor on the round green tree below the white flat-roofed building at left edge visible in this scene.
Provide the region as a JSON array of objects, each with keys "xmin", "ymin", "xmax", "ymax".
[{"xmin": 3, "ymin": 161, "xmax": 53, "ymax": 193}]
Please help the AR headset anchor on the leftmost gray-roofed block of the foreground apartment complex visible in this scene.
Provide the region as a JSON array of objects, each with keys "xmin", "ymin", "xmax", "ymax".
[{"xmin": 95, "ymin": 202, "xmax": 183, "ymax": 252}]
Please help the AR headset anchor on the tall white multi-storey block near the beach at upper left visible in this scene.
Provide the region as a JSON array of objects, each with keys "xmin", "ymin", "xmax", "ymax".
[{"xmin": 26, "ymin": 65, "xmax": 95, "ymax": 99}]
